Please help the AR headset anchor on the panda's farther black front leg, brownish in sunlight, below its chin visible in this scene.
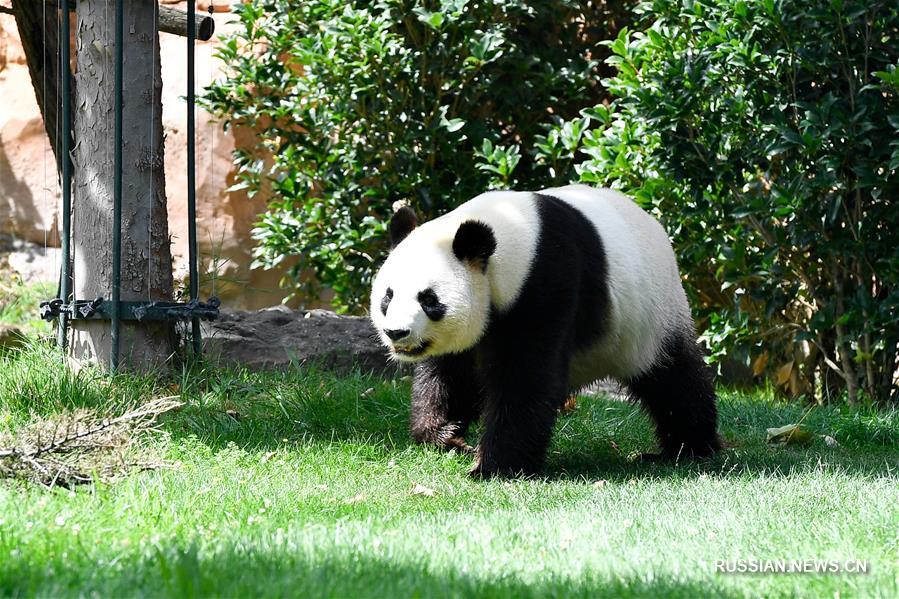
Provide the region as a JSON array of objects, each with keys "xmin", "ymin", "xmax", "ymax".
[{"xmin": 410, "ymin": 352, "xmax": 481, "ymax": 451}]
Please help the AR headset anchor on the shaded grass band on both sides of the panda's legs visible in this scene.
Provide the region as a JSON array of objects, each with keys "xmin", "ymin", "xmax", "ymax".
[{"xmin": 168, "ymin": 360, "xmax": 899, "ymax": 480}]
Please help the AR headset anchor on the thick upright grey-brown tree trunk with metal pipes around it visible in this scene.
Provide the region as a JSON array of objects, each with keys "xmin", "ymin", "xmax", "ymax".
[{"xmin": 70, "ymin": 0, "xmax": 174, "ymax": 370}]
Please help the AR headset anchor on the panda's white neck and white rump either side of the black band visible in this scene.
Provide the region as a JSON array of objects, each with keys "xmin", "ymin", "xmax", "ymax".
[{"xmin": 409, "ymin": 185, "xmax": 692, "ymax": 388}]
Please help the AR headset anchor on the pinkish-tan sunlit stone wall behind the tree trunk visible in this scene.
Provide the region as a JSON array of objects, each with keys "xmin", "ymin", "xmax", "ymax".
[{"xmin": 0, "ymin": 2, "xmax": 300, "ymax": 309}]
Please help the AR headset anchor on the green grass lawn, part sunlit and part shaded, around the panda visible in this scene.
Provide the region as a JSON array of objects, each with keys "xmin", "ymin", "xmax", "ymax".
[{"xmin": 0, "ymin": 346, "xmax": 899, "ymax": 598}]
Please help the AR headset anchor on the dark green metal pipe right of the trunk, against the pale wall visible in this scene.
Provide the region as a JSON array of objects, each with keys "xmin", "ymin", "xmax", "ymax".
[{"xmin": 187, "ymin": 0, "xmax": 201, "ymax": 356}]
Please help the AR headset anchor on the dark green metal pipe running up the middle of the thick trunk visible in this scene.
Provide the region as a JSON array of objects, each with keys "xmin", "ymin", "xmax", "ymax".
[{"xmin": 110, "ymin": 0, "xmax": 124, "ymax": 372}]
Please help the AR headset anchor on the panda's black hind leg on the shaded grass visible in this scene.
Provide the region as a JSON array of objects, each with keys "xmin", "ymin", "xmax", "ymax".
[{"xmin": 627, "ymin": 333, "xmax": 722, "ymax": 458}]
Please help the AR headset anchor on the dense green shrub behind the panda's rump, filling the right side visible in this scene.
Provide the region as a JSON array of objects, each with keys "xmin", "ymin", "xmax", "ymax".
[{"xmin": 541, "ymin": 0, "xmax": 899, "ymax": 401}]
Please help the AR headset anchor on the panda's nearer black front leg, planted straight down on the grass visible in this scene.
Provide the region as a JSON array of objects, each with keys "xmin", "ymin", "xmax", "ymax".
[{"xmin": 471, "ymin": 351, "xmax": 567, "ymax": 478}]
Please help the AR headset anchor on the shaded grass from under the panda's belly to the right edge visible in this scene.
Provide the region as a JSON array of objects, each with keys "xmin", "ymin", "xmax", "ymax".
[{"xmin": 546, "ymin": 393, "xmax": 899, "ymax": 481}]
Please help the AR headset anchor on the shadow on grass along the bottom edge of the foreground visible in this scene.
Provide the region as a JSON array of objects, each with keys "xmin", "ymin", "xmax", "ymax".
[{"xmin": 0, "ymin": 539, "xmax": 743, "ymax": 599}]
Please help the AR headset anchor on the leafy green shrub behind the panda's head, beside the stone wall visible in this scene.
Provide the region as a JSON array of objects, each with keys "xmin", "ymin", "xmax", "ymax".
[{"xmin": 205, "ymin": 0, "xmax": 633, "ymax": 310}]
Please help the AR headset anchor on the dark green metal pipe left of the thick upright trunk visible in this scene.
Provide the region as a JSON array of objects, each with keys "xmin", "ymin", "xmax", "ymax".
[{"xmin": 57, "ymin": 0, "xmax": 72, "ymax": 351}]
